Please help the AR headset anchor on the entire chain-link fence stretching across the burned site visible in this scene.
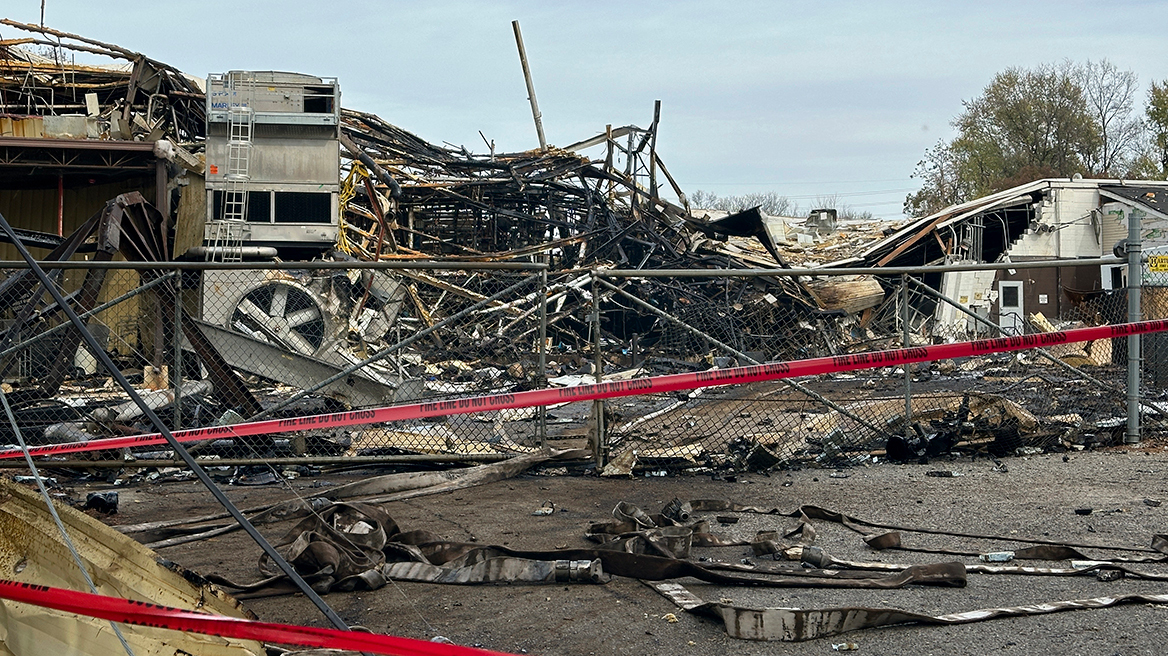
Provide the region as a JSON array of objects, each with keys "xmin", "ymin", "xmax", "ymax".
[{"xmin": 0, "ymin": 255, "xmax": 1168, "ymax": 473}]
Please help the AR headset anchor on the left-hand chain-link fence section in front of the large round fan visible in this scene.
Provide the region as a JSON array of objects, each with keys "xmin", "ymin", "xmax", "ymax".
[{"xmin": 0, "ymin": 260, "xmax": 547, "ymax": 460}]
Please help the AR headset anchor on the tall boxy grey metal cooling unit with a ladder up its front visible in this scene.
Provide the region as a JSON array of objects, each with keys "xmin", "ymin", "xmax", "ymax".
[{"xmin": 204, "ymin": 71, "xmax": 340, "ymax": 259}]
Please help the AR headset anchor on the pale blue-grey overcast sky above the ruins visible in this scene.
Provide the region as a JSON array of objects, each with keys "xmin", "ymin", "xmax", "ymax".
[{"xmin": 0, "ymin": 0, "xmax": 1168, "ymax": 218}]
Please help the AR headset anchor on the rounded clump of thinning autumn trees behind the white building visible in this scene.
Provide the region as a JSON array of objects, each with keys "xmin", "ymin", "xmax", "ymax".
[{"xmin": 904, "ymin": 60, "xmax": 1149, "ymax": 216}]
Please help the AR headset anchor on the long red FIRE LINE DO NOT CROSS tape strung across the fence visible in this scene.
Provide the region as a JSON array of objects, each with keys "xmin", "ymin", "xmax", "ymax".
[{"xmin": 9, "ymin": 320, "xmax": 1168, "ymax": 459}]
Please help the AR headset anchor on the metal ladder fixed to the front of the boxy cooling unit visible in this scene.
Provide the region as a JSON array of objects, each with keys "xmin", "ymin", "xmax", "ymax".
[{"xmin": 207, "ymin": 71, "xmax": 256, "ymax": 261}]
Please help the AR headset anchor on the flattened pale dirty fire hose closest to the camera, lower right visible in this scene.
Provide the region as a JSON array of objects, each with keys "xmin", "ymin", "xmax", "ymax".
[{"xmin": 682, "ymin": 593, "xmax": 1168, "ymax": 642}]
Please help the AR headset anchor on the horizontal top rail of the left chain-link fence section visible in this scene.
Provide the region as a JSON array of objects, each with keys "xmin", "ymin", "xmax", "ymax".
[{"xmin": 0, "ymin": 260, "xmax": 546, "ymax": 271}]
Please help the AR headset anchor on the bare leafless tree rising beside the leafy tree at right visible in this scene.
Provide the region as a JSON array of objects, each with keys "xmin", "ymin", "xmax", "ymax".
[{"xmin": 1078, "ymin": 60, "xmax": 1143, "ymax": 176}]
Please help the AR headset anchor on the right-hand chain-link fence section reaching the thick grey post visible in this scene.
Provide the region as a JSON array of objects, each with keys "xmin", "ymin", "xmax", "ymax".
[{"xmin": 600, "ymin": 262, "xmax": 1161, "ymax": 473}]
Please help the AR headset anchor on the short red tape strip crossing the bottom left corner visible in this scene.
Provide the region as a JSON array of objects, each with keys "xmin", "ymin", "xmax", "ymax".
[{"xmin": 0, "ymin": 579, "xmax": 510, "ymax": 656}]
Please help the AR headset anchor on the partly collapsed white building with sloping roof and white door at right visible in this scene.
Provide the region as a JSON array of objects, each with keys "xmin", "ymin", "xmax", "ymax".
[{"xmin": 829, "ymin": 179, "xmax": 1168, "ymax": 337}]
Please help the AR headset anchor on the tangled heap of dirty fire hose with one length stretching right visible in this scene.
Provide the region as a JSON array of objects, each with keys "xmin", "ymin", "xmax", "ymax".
[{"xmin": 214, "ymin": 494, "xmax": 966, "ymax": 598}]
